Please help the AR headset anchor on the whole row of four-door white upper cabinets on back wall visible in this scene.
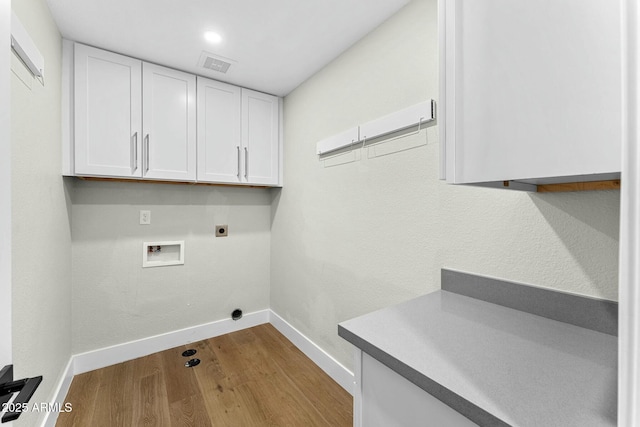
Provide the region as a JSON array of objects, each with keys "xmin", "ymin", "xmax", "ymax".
[{"xmin": 69, "ymin": 41, "xmax": 282, "ymax": 186}]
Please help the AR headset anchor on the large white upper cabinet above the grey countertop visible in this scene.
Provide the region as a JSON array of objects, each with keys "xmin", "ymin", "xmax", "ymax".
[{"xmin": 438, "ymin": 0, "xmax": 623, "ymax": 188}]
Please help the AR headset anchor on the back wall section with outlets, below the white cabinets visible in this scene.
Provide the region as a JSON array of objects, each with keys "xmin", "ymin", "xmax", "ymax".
[{"xmin": 72, "ymin": 180, "xmax": 271, "ymax": 354}]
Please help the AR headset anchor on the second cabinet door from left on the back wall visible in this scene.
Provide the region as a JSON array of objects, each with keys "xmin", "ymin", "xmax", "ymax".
[{"xmin": 142, "ymin": 63, "xmax": 196, "ymax": 181}]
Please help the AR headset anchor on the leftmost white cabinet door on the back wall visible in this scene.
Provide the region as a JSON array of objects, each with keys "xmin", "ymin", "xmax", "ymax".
[{"xmin": 74, "ymin": 44, "xmax": 142, "ymax": 177}]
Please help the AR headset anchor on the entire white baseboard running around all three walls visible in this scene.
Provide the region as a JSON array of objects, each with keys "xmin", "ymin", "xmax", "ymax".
[{"xmin": 42, "ymin": 309, "xmax": 354, "ymax": 427}]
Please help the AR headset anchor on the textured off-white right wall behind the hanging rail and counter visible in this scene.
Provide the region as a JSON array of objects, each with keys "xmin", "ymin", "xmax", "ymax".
[{"xmin": 271, "ymin": 0, "xmax": 620, "ymax": 372}]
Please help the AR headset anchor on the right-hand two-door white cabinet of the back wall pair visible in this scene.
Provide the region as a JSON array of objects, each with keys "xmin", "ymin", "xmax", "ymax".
[{"xmin": 198, "ymin": 77, "xmax": 280, "ymax": 185}]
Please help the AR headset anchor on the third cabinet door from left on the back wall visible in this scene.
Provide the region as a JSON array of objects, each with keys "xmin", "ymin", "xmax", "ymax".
[{"xmin": 198, "ymin": 77, "xmax": 243, "ymax": 183}]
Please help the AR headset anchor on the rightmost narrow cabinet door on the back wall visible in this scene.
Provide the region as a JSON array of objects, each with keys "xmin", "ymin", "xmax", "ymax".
[{"xmin": 241, "ymin": 89, "xmax": 280, "ymax": 185}]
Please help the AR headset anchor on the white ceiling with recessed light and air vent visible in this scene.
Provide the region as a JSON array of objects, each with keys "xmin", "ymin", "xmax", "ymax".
[{"xmin": 48, "ymin": 0, "xmax": 409, "ymax": 96}]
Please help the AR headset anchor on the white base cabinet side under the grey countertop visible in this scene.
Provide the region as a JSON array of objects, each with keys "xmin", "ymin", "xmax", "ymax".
[{"xmin": 354, "ymin": 350, "xmax": 478, "ymax": 427}]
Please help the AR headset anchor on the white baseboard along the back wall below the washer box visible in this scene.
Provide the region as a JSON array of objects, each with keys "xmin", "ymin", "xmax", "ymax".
[{"xmin": 73, "ymin": 310, "xmax": 269, "ymax": 375}]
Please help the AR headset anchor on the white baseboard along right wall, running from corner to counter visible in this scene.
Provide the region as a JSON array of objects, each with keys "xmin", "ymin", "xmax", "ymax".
[{"xmin": 269, "ymin": 310, "xmax": 355, "ymax": 396}]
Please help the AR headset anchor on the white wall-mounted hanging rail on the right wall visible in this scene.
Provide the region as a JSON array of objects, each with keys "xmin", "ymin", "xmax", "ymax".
[{"xmin": 316, "ymin": 100, "xmax": 436, "ymax": 156}]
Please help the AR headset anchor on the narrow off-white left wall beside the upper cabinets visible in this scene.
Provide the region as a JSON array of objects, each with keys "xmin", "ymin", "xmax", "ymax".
[{"xmin": 11, "ymin": 0, "xmax": 71, "ymax": 426}]
